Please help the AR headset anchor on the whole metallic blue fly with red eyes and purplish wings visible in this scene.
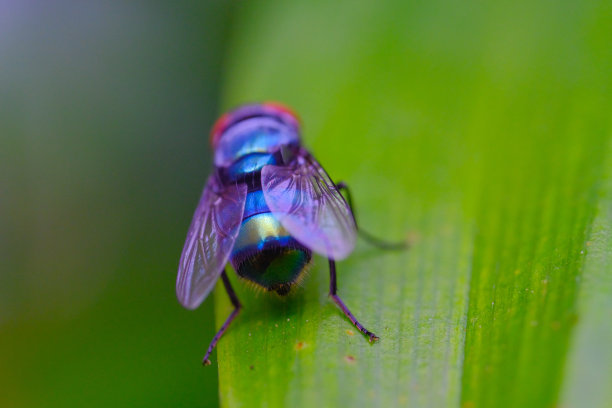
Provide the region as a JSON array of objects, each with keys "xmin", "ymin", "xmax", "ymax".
[{"xmin": 176, "ymin": 103, "xmax": 406, "ymax": 365}]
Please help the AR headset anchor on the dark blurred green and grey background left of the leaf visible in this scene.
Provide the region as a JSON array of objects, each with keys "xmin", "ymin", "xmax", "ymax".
[{"xmin": 0, "ymin": 1, "xmax": 230, "ymax": 408}]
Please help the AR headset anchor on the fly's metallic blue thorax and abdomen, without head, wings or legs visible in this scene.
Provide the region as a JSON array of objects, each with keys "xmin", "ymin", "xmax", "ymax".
[{"xmin": 215, "ymin": 113, "xmax": 312, "ymax": 295}]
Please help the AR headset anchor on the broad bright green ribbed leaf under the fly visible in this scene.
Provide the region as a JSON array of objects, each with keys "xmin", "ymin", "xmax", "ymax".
[{"xmin": 215, "ymin": 1, "xmax": 612, "ymax": 407}]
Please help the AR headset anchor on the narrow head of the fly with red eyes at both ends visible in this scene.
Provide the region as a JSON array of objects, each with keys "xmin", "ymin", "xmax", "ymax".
[{"xmin": 210, "ymin": 101, "xmax": 301, "ymax": 149}]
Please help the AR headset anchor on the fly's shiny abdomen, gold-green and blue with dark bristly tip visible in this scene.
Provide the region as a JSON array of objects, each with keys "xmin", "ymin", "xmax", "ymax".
[{"xmin": 231, "ymin": 212, "xmax": 312, "ymax": 295}]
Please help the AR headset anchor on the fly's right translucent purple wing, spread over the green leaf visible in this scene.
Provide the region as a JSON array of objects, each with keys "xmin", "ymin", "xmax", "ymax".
[{"xmin": 261, "ymin": 151, "xmax": 357, "ymax": 260}]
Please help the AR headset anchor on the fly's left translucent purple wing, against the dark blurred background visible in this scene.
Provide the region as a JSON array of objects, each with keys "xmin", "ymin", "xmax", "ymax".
[{"xmin": 176, "ymin": 175, "xmax": 247, "ymax": 309}]
